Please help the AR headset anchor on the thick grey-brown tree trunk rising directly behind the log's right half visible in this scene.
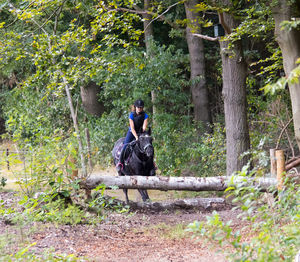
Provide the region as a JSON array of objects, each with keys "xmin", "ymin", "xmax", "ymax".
[{"xmin": 220, "ymin": 8, "xmax": 250, "ymax": 176}]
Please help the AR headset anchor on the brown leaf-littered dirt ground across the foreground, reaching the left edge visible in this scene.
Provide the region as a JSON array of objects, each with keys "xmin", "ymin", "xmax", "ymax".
[{"xmin": 0, "ymin": 192, "xmax": 241, "ymax": 262}]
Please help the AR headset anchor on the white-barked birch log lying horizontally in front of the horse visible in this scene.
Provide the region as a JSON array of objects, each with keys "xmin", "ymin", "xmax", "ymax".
[{"xmin": 81, "ymin": 174, "xmax": 277, "ymax": 191}]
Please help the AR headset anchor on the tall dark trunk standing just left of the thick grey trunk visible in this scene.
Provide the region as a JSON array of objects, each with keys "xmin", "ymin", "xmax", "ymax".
[{"xmin": 184, "ymin": 0, "xmax": 211, "ymax": 130}]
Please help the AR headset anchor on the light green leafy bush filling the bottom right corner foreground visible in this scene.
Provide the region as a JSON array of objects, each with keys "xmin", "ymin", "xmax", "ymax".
[{"xmin": 187, "ymin": 163, "xmax": 300, "ymax": 261}]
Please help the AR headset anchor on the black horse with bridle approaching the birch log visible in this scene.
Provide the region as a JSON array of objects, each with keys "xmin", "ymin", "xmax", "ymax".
[{"xmin": 112, "ymin": 130, "xmax": 155, "ymax": 204}]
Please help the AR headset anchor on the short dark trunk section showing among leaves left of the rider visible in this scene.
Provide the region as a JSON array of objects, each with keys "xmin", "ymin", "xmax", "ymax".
[{"xmin": 80, "ymin": 82, "xmax": 104, "ymax": 116}]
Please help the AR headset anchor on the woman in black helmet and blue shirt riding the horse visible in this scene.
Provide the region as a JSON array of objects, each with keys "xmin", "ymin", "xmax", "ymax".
[{"xmin": 116, "ymin": 99, "xmax": 149, "ymax": 171}]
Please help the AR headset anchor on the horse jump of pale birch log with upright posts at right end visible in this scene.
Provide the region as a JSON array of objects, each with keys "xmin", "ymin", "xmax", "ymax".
[{"xmin": 80, "ymin": 149, "xmax": 298, "ymax": 192}]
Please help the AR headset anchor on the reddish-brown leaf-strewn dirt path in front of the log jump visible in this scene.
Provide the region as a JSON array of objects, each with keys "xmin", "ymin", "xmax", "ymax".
[{"xmin": 29, "ymin": 214, "xmax": 230, "ymax": 262}]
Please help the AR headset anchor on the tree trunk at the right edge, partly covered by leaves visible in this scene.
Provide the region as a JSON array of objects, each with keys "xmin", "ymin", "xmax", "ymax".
[{"xmin": 273, "ymin": 0, "xmax": 300, "ymax": 150}]
